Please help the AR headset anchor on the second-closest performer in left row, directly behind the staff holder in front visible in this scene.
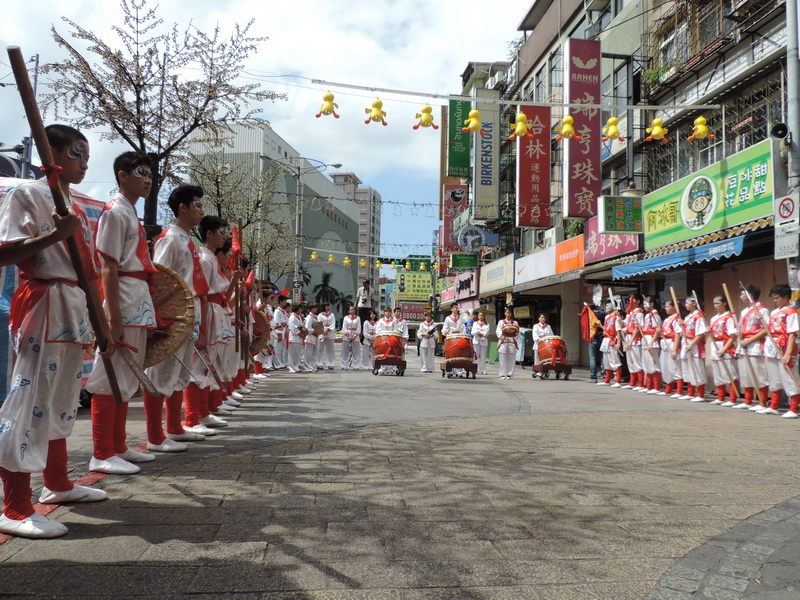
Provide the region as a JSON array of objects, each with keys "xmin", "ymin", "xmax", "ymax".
[{"xmin": 86, "ymin": 152, "xmax": 156, "ymax": 474}]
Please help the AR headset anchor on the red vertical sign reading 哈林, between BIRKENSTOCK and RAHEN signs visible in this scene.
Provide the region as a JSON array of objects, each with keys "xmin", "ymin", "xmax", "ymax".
[{"xmin": 517, "ymin": 105, "xmax": 550, "ymax": 228}]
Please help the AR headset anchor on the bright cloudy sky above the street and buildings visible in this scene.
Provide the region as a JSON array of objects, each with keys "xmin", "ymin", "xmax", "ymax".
[{"xmin": 0, "ymin": 0, "xmax": 530, "ymax": 262}]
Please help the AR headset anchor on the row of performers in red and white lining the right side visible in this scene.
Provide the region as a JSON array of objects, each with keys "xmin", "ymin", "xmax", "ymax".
[{"xmin": 597, "ymin": 284, "xmax": 800, "ymax": 419}]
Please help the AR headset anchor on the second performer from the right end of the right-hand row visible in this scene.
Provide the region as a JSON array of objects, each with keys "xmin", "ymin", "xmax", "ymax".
[{"xmin": 733, "ymin": 283, "xmax": 769, "ymax": 411}]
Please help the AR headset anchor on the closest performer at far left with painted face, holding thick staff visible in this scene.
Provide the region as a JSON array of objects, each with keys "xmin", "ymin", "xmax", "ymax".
[{"xmin": 0, "ymin": 125, "xmax": 107, "ymax": 538}]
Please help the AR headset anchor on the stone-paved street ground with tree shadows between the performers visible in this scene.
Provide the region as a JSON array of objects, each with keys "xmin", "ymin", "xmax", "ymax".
[{"xmin": 0, "ymin": 364, "xmax": 800, "ymax": 600}]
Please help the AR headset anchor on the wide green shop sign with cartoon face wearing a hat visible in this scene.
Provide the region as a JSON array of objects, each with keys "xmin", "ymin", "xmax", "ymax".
[{"xmin": 642, "ymin": 140, "xmax": 774, "ymax": 250}]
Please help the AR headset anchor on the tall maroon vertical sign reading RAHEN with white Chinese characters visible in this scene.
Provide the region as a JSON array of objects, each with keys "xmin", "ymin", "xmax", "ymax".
[{"xmin": 562, "ymin": 38, "xmax": 602, "ymax": 218}]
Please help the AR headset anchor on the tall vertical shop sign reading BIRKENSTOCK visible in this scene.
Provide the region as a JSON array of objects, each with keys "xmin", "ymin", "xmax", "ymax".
[{"xmin": 472, "ymin": 88, "xmax": 500, "ymax": 220}]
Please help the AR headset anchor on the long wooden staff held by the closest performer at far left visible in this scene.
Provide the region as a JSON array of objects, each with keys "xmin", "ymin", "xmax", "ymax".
[{"xmin": 8, "ymin": 46, "xmax": 122, "ymax": 404}]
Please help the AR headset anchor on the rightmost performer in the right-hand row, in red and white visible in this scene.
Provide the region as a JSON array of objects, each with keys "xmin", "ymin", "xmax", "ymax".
[{"xmin": 758, "ymin": 283, "xmax": 800, "ymax": 419}]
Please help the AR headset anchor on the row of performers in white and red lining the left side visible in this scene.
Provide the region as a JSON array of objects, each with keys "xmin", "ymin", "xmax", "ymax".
[{"xmin": 0, "ymin": 125, "xmax": 266, "ymax": 538}]
